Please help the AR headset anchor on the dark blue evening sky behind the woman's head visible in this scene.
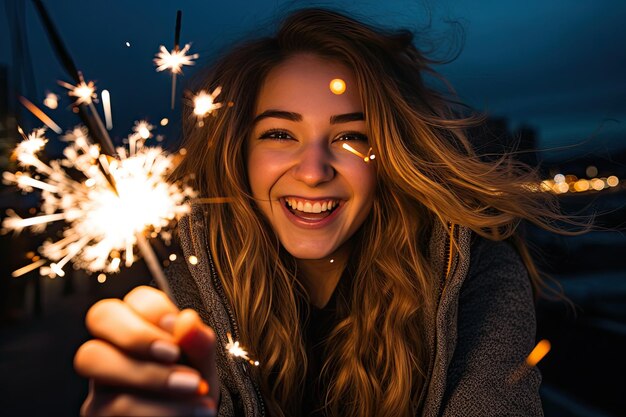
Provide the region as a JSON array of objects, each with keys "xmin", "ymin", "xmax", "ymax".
[{"xmin": 0, "ymin": 0, "xmax": 626, "ymax": 160}]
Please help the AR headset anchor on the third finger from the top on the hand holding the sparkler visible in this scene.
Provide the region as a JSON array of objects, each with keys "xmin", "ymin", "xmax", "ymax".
[{"xmin": 74, "ymin": 340, "xmax": 209, "ymax": 396}]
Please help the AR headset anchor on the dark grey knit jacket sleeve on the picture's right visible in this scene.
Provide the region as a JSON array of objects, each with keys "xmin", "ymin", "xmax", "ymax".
[{"xmin": 442, "ymin": 240, "xmax": 543, "ymax": 417}]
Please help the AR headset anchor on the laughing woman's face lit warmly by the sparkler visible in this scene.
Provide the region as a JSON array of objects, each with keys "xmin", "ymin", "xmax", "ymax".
[{"xmin": 248, "ymin": 54, "xmax": 376, "ymax": 259}]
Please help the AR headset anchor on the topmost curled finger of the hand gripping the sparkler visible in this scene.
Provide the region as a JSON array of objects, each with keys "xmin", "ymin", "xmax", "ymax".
[{"xmin": 124, "ymin": 286, "xmax": 179, "ymax": 333}]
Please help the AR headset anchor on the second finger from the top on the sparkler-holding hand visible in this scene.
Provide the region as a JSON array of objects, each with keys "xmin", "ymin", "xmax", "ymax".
[{"xmin": 85, "ymin": 299, "xmax": 180, "ymax": 362}]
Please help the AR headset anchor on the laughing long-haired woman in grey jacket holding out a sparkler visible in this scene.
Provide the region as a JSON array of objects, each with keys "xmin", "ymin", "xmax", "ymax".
[{"xmin": 75, "ymin": 9, "xmax": 559, "ymax": 416}]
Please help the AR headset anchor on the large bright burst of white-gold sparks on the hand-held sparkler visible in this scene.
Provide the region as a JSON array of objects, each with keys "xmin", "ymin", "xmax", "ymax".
[{"xmin": 2, "ymin": 126, "xmax": 195, "ymax": 277}]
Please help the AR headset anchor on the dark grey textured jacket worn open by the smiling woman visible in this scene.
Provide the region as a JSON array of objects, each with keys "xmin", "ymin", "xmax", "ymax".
[{"xmin": 168, "ymin": 210, "xmax": 543, "ymax": 417}]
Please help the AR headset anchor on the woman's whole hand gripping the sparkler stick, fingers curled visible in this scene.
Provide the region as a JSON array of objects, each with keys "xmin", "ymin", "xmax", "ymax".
[{"xmin": 74, "ymin": 287, "xmax": 219, "ymax": 417}]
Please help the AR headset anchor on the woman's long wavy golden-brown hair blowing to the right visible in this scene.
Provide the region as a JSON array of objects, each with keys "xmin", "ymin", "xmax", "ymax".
[{"xmin": 177, "ymin": 9, "xmax": 572, "ymax": 417}]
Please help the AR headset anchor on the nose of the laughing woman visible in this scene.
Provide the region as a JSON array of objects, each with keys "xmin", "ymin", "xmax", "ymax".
[{"xmin": 292, "ymin": 143, "xmax": 335, "ymax": 187}]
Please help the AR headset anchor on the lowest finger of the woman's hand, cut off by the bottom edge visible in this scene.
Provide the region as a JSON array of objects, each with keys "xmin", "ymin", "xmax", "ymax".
[{"xmin": 80, "ymin": 386, "xmax": 216, "ymax": 417}]
